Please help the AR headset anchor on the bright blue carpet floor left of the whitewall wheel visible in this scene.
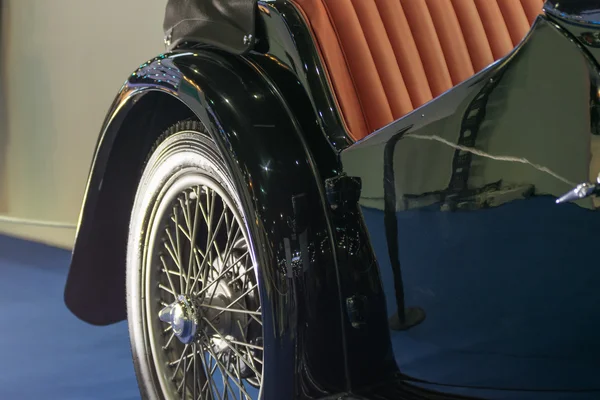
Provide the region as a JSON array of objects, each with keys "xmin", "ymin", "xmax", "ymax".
[{"xmin": 0, "ymin": 236, "xmax": 140, "ymax": 400}]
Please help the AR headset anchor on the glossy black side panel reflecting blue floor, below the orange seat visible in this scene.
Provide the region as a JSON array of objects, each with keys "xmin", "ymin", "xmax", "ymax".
[{"xmin": 342, "ymin": 14, "xmax": 600, "ymax": 399}]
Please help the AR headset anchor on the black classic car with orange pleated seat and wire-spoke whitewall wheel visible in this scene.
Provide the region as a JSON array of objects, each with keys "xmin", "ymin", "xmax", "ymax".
[{"xmin": 65, "ymin": 0, "xmax": 600, "ymax": 400}]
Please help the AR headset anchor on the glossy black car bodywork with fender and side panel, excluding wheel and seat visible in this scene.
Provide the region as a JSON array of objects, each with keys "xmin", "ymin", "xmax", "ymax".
[{"xmin": 65, "ymin": 0, "xmax": 600, "ymax": 399}]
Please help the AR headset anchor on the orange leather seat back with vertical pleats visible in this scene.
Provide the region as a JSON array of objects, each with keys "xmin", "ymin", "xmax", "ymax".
[{"xmin": 293, "ymin": 0, "xmax": 544, "ymax": 140}]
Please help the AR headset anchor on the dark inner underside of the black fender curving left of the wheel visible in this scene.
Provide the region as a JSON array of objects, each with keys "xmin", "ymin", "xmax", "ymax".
[{"xmin": 65, "ymin": 90, "xmax": 195, "ymax": 325}]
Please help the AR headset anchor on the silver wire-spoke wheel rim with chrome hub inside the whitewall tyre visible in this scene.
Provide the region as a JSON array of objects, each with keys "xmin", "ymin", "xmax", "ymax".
[{"xmin": 130, "ymin": 123, "xmax": 263, "ymax": 400}]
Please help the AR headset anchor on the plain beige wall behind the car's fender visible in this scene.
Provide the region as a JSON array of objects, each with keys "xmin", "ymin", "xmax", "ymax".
[{"xmin": 0, "ymin": 0, "xmax": 166, "ymax": 248}]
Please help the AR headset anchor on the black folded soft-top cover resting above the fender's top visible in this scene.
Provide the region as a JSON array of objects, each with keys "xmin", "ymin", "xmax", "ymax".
[{"xmin": 163, "ymin": 0, "xmax": 258, "ymax": 54}]
